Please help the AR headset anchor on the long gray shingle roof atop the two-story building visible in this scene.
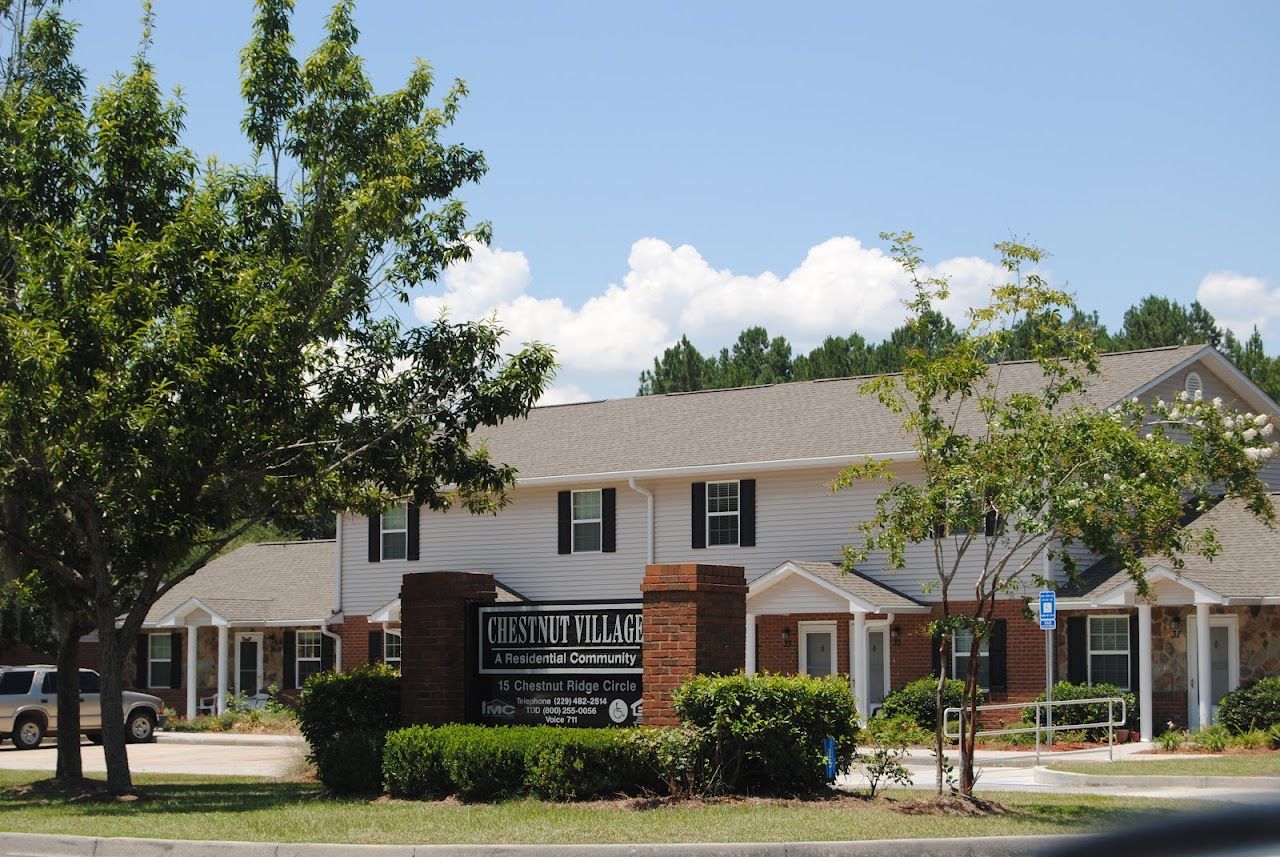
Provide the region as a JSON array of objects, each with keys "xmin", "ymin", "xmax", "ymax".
[{"xmin": 476, "ymin": 345, "xmax": 1207, "ymax": 480}]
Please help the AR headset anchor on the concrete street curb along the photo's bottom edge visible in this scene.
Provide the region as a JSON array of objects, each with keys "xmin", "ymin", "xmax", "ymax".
[{"xmin": 0, "ymin": 833, "xmax": 1078, "ymax": 857}]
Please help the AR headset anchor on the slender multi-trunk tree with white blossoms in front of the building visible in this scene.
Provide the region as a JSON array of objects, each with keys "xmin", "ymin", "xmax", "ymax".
[{"xmin": 833, "ymin": 233, "xmax": 1275, "ymax": 796}]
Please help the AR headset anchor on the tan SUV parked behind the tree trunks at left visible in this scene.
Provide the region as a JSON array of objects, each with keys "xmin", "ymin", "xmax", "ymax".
[{"xmin": 0, "ymin": 664, "xmax": 164, "ymax": 750}]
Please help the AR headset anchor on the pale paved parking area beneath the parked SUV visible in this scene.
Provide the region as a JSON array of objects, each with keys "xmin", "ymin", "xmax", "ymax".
[{"xmin": 0, "ymin": 741, "xmax": 306, "ymax": 776}]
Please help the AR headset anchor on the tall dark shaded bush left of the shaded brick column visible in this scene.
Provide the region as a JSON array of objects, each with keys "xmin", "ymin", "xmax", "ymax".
[{"xmin": 297, "ymin": 664, "xmax": 401, "ymax": 794}]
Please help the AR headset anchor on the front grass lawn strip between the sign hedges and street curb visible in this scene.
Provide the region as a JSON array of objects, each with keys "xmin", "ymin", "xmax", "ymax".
[{"xmin": 0, "ymin": 771, "xmax": 1197, "ymax": 844}]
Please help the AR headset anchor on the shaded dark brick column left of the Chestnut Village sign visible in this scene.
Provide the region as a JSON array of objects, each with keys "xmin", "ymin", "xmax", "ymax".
[{"xmin": 401, "ymin": 572, "xmax": 498, "ymax": 725}]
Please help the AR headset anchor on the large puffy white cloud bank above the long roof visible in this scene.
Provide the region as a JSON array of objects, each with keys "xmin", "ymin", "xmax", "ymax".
[{"xmin": 413, "ymin": 237, "xmax": 1004, "ymax": 402}]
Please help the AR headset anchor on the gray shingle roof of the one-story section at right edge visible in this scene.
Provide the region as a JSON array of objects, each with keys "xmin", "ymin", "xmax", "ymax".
[{"xmin": 1068, "ymin": 494, "xmax": 1280, "ymax": 600}]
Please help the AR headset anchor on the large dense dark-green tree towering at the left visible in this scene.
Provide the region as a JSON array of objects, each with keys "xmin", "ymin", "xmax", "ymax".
[{"xmin": 0, "ymin": 0, "xmax": 553, "ymax": 794}]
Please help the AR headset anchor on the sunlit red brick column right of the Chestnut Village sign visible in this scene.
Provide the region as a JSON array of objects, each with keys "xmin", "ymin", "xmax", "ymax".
[{"xmin": 640, "ymin": 563, "xmax": 746, "ymax": 727}]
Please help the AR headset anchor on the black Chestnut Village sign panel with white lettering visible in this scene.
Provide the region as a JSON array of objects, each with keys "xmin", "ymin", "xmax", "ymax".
[{"xmin": 474, "ymin": 601, "xmax": 644, "ymax": 727}]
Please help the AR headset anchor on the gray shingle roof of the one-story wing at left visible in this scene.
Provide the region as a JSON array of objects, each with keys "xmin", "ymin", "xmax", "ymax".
[{"xmin": 145, "ymin": 540, "xmax": 337, "ymax": 625}]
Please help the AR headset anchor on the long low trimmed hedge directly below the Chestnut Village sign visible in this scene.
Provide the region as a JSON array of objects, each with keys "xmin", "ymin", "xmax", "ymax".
[{"xmin": 381, "ymin": 724, "xmax": 660, "ymax": 801}]
